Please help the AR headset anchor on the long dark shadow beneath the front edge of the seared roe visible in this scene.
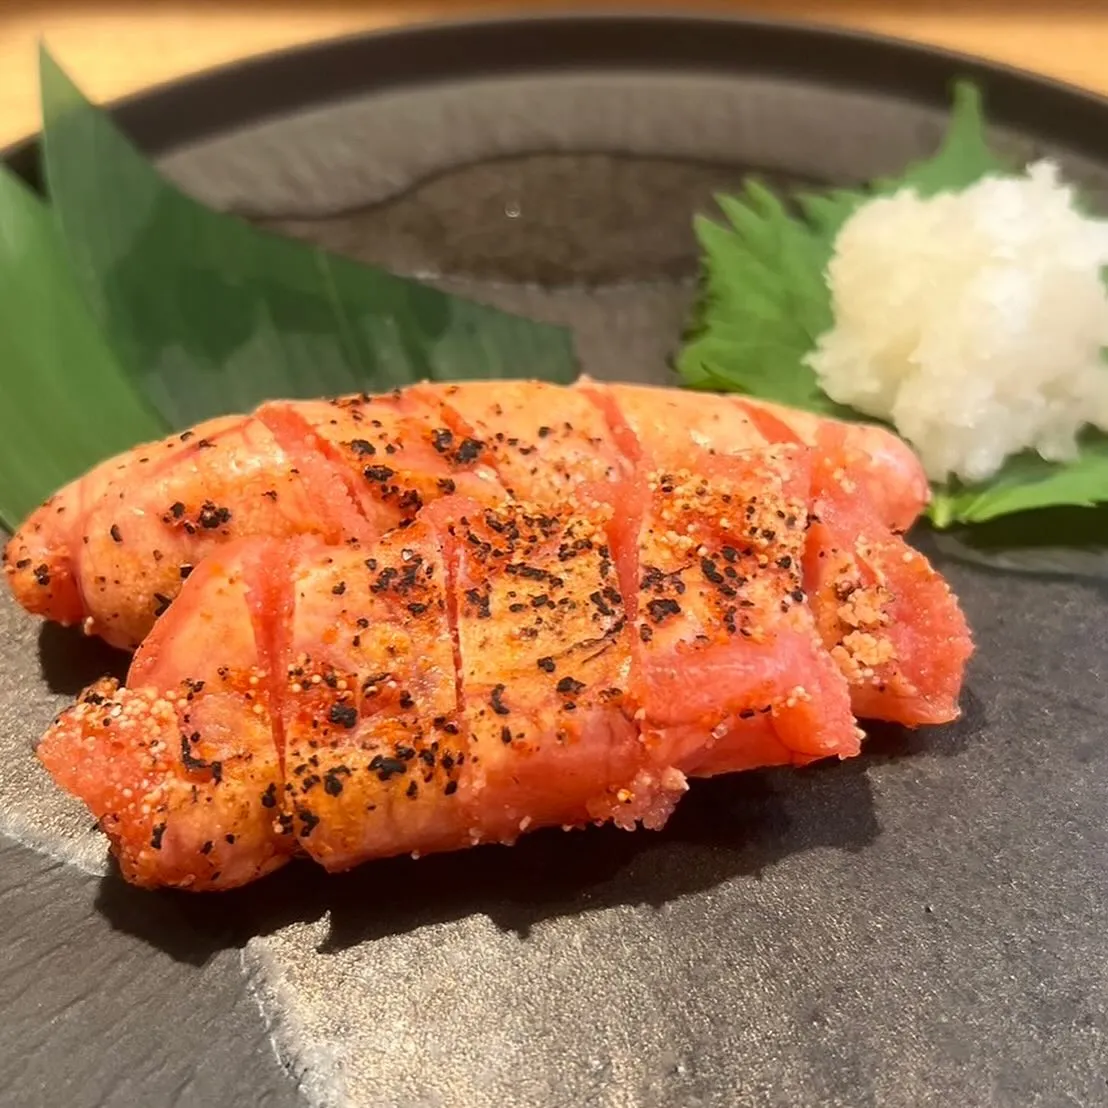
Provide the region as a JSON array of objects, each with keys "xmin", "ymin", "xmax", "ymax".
[{"xmin": 90, "ymin": 693, "xmax": 984, "ymax": 964}]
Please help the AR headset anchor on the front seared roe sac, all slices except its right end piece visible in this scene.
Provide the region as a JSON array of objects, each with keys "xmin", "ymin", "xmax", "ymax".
[{"xmin": 39, "ymin": 440, "xmax": 952, "ymax": 890}]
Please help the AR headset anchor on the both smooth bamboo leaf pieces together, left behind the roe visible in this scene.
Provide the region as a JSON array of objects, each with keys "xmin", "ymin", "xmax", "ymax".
[{"xmin": 0, "ymin": 50, "xmax": 577, "ymax": 530}]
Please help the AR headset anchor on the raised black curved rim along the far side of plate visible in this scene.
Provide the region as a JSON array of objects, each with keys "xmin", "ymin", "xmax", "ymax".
[{"xmin": 10, "ymin": 9, "xmax": 1108, "ymax": 192}]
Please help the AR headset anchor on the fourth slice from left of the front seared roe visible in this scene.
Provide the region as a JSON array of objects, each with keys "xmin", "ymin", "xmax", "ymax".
[{"xmin": 598, "ymin": 438, "xmax": 860, "ymax": 777}]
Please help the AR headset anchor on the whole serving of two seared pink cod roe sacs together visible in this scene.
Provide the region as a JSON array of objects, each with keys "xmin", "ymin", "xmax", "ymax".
[{"xmin": 26, "ymin": 380, "xmax": 972, "ymax": 891}]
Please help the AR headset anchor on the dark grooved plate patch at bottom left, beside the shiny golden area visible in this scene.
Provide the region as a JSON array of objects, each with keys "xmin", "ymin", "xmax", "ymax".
[{"xmin": 0, "ymin": 837, "xmax": 300, "ymax": 1108}]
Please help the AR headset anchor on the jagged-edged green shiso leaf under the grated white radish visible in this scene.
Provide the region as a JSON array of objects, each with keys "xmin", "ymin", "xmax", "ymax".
[{"xmin": 677, "ymin": 81, "xmax": 1108, "ymax": 527}]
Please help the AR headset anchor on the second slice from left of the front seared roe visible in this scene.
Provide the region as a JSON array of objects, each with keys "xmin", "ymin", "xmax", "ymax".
[{"xmin": 281, "ymin": 520, "xmax": 470, "ymax": 870}]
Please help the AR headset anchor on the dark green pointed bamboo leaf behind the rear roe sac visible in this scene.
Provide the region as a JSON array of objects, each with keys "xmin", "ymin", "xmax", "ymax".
[{"xmin": 40, "ymin": 51, "xmax": 576, "ymax": 427}]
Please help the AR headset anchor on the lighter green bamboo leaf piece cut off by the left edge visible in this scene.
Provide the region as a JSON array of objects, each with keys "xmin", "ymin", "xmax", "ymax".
[{"xmin": 0, "ymin": 167, "xmax": 170, "ymax": 530}]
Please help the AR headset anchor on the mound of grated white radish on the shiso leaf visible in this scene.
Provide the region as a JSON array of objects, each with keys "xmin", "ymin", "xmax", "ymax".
[{"xmin": 808, "ymin": 162, "xmax": 1108, "ymax": 482}]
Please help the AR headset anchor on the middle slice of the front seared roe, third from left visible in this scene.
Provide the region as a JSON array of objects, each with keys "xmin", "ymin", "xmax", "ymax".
[{"xmin": 431, "ymin": 501, "xmax": 685, "ymax": 842}]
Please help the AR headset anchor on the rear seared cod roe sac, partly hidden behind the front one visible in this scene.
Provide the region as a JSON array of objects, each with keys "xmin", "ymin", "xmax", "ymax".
[{"xmin": 4, "ymin": 381, "xmax": 926, "ymax": 647}]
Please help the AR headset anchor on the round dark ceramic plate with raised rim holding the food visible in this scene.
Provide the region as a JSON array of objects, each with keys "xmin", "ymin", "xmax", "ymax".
[{"xmin": 0, "ymin": 18, "xmax": 1108, "ymax": 1108}]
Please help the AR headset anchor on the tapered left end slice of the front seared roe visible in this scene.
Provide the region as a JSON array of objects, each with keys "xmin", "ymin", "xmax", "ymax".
[{"xmin": 38, "ymin": 540, "xmax": 294, "ymax": 891}]
